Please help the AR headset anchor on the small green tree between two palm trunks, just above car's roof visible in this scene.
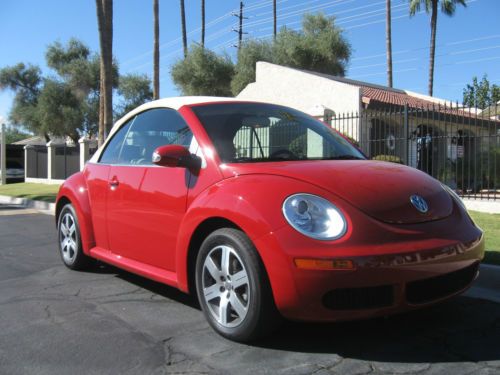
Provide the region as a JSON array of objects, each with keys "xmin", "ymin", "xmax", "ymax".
[{"xmin": 115, "ymin": 74, "xmax": 153, "ymax": 118}]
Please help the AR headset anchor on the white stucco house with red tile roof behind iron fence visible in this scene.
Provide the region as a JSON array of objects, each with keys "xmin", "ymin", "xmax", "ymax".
[{"xmin": 238, "ymin": 62, "xmax": 499, "ymax": 185}]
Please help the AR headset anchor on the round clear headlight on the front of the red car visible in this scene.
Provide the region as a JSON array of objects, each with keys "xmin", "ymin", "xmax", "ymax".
[{"xmin": 283, "ymin": 194, "xmax": 347, "ymax": 241}]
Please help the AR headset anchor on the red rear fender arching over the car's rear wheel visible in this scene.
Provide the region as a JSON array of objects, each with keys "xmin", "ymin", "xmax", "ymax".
[{"xmin": 56, "ymin": 172, "xmax": 95, "ymax": 255}]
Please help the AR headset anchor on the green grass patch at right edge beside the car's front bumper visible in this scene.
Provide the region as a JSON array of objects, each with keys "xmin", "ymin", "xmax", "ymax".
[{"xmin": 469, "ymin": 211, "xmax": 500, "ymax": 265}]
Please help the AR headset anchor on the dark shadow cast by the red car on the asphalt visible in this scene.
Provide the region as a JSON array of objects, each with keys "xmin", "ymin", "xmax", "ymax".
[{"xmin": 81, "ymin": 263, "xmax": 500, "ymax": 363}]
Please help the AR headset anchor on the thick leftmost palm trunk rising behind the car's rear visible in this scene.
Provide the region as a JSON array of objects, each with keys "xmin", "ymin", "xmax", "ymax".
[{"xmin": 95, "ymin": 0, "xmax": 113, "ymax": 146}]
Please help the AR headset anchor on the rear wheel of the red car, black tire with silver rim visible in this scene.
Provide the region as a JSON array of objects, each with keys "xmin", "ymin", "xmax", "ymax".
[{"xmin": 57, "ymin": 203, "xmax": 91, "ymax": 270}]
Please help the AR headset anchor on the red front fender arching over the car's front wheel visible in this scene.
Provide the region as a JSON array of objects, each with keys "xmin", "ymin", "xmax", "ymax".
[{"xmin": 176, "ymin": 174, "xmax": 319, "ymax": 306}]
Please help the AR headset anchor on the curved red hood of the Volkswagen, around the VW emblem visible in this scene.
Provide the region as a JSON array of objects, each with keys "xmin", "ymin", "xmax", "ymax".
[{"xmin": 221, "ymin": 160, "xmax": 453, "ymax": 224}]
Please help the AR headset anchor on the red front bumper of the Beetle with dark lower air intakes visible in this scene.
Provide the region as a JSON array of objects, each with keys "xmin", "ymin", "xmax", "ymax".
[{"xmin": 256, "ymin": 225, "xmax": 484, "ymax": 321}]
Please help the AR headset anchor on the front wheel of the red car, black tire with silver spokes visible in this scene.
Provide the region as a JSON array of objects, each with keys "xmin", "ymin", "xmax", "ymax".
[{"xmin": 196, "ymin": 228, "xmax": 280, "ymax": 342}]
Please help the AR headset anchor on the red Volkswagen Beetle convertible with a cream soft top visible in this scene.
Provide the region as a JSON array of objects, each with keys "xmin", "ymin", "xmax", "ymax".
[{"xmin": 56, "ymin": 97, "xmax": 484, "ymax": 341}]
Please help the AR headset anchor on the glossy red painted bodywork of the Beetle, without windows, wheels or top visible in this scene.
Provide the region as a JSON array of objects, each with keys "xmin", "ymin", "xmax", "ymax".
[{"xmin": 57, "ymin": 100, "xmax": 484, "ymax": 321}]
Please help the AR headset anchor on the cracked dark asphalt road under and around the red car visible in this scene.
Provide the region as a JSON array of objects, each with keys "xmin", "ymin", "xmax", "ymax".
[{"xmin": 0, "ymin": 206, "xmax": 500, "ymax": 375}]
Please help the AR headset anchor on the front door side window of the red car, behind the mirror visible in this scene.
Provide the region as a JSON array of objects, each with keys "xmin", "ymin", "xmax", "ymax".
[{"xmin": 119, "ymin": 108, "xmax": 193, "ymax": 165}]
